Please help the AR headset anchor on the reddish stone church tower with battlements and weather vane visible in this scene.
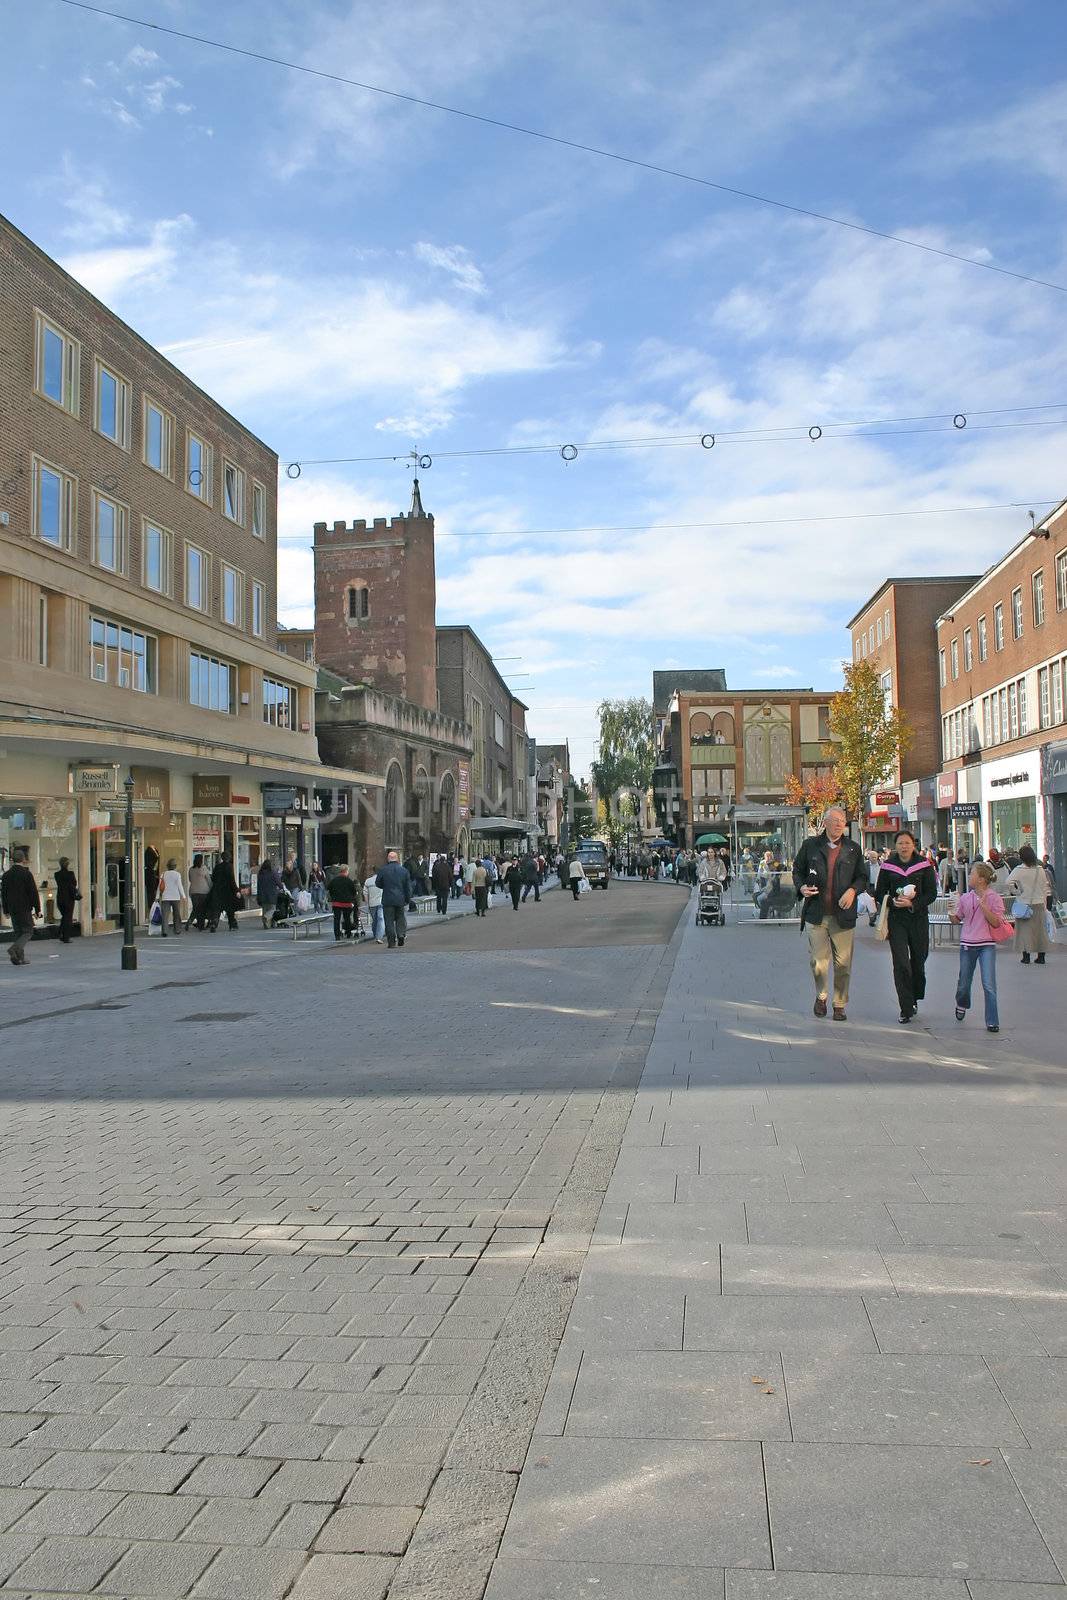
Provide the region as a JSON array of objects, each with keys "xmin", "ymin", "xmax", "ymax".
[{"xmin": 315, "ymin": 478, "xmax": 437, "ymax": 710}]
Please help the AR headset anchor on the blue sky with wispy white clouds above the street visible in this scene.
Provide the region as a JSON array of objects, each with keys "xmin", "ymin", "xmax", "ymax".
[{"xmin": 8, "ymin": 0, "xmax": 1067, "ymax": 766}]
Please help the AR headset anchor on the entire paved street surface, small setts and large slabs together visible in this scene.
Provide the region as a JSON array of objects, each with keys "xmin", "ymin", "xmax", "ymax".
[{"xmin": 0, "ymin": 883, "xmax": 1067, "ymax": 1600}]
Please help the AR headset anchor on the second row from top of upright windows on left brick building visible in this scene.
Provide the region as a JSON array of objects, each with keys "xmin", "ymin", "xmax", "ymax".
[{"xmin": 34, "ymin": 458, "xmax": 267, "ymax": 638}]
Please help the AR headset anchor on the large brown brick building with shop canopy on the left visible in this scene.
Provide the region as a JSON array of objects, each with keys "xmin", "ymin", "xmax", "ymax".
[{"xmin": 0, "ymin": 219, "xmax": 367, "ymax": 933}]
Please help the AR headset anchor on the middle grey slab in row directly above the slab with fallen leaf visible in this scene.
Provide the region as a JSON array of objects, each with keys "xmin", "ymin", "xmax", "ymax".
[{"xmin": 685, "ymin": 1290, "xmax": 878, "ymax": 1354}]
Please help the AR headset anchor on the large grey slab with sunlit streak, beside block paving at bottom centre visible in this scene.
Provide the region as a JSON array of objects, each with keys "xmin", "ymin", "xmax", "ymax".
[{"xmin": 501, "ymin": 1438, "xmax": 771, "ymax": 1568}]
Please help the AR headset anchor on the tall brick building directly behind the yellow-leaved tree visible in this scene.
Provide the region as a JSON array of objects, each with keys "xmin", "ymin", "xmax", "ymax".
[{"xmin": 848, "ymin": 574, "xmax": 974, "ymax": 845}]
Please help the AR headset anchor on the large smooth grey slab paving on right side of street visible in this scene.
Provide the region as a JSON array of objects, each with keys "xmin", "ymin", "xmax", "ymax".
[{"xmin": 486, "ymin": 896, "xmax": 1067, "ymax": 1600}]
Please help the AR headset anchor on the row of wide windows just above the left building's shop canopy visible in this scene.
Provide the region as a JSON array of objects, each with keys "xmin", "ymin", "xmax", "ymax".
[{"xmin": 82, "ymin": 608, "xmax": 296, "ymax": 728}]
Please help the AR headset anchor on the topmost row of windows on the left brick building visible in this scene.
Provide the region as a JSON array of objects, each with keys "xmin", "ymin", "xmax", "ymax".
[{"xmin": 34, "ymin": 312, "xmax": 267, "ymax": 539}]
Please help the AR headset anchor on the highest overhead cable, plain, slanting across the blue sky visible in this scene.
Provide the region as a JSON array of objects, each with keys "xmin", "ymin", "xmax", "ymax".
[{"xmin": 47, "ymin": 0, "xmax": 1067, "ymax": 294}]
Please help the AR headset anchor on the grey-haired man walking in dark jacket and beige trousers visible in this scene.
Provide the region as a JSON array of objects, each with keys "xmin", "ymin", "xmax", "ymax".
[{"xmin": 793, "ymin": 806, "xmax": 867, "ymax": 1022}]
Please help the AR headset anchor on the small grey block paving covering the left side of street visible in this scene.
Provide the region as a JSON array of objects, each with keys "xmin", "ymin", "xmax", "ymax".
[{"xmin": 0, "ymin": 886, "xmax": 681, "ymax": 1600}]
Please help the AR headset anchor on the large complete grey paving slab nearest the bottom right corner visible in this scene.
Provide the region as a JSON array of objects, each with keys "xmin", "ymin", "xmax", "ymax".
[{"xmin": 765, "ymin": 1445, "xmax": 1059, "ymax": 1582}]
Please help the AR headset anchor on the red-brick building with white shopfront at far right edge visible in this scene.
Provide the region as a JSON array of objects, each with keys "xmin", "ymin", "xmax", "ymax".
[{"xmin": 936, "ymin": 501, "xmax": 1067, "ymax": 883}]
